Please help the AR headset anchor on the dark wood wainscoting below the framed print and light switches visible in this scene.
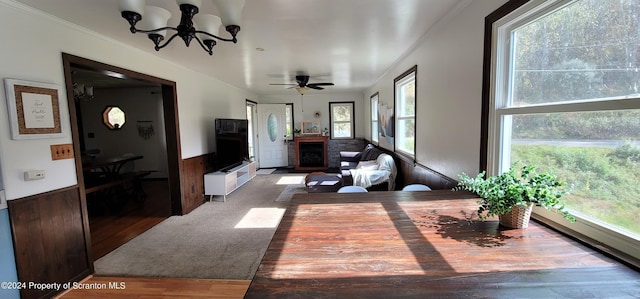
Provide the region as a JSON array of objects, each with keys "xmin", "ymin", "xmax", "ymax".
[{"xmin": 8, "ymin": 186, "xmax": 92, "ymax": 299}]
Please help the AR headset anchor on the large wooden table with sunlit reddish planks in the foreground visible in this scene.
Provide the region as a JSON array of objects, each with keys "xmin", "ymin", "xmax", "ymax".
[{"xmin": 245, "ymin": 191, "xmax": 640, "ymax": 298}]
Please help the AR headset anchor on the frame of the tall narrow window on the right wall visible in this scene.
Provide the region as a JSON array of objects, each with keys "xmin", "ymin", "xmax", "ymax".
[{"xmin": 393, "ymin": 65, "xmax": 418, "ymax": 161}]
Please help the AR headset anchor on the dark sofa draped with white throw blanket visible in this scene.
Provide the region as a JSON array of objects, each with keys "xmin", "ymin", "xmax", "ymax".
[{"xmin": 340, "ymin": 144, "xmax": 397, "ymax": 191}]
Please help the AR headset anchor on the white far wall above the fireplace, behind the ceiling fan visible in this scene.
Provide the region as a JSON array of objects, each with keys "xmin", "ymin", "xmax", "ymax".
[{"xmin": 258, "ymin": 92, "xmax": 368, "ymax": 137}]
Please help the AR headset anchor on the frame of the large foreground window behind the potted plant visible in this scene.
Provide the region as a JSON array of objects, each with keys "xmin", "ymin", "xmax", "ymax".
[{"xmin": 480, "ymin": 0, "xmax": 640, "ymax": 266}]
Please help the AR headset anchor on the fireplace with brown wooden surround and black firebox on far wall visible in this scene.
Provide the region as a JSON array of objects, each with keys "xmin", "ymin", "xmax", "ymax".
[{"xmin": 295, "ymin": 136, "xmax": 329, "ymax": 171}]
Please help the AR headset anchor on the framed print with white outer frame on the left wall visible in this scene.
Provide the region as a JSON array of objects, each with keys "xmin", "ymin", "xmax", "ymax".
[{"xmin": 4, "ymin": 79, "xmax": 64, "ymax": 139}]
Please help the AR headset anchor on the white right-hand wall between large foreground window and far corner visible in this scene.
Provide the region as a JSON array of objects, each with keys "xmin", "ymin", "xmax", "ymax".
[{"xmin": 365, "ymin": 0, "xmax": 506, "ymax": 179}]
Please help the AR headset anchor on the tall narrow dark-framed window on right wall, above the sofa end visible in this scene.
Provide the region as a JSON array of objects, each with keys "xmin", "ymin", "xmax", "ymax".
[{"xmin": 394, "ymin": 66, "xmax": 418, "ymax": 157}]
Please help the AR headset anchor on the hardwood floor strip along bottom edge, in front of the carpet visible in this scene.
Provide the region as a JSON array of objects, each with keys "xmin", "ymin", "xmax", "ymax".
[{"xmin": 56, "ymin": 276, "xmax": 251, "ymax": 299}]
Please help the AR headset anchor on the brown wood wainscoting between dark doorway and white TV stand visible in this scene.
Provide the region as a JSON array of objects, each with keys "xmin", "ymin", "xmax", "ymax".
[{"xmin": 180, "ymin": 154, "xmax": 213, "ymax": 215}]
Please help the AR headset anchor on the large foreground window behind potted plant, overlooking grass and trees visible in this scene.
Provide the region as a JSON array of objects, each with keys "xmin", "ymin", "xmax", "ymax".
[{"xmin": 486, "ymin": 0, "xmax": 640, "ymax": 258}]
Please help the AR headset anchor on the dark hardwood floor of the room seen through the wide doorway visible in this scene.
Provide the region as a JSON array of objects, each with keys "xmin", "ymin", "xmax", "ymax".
[{"xmin": 87, "ymin": 179, "xmax": 171, "ymax": 260}]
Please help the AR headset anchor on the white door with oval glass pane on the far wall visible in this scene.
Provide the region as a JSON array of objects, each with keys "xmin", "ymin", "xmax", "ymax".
[{"xmin": 258, "ymin": 104, "xmax": 289, "ymax": 168}]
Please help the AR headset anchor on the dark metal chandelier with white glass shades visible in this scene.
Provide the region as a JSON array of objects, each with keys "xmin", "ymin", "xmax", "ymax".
[{"xmin": 119, "ymin": 0, "xmax": 245, "ymax": 55}]
